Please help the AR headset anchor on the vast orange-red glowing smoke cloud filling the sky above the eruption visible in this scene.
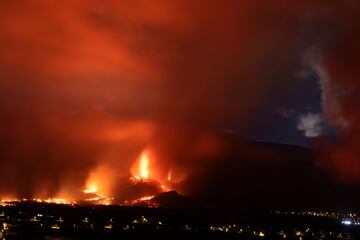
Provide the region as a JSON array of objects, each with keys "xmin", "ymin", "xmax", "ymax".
[{"xmin": 0, "ymin": 0, "xmax": 360, "ymax": 201}]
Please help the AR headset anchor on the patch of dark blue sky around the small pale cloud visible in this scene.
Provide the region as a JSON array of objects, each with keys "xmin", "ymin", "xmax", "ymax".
[{"xmin": 246, "ymin": 70, "xmax": 335, "ymax": 146}]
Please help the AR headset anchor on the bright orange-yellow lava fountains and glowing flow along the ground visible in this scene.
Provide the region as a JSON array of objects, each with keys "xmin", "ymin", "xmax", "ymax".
[{"xmin": 0, "ymin": 148, "xmax": 177, "ymax": 207}]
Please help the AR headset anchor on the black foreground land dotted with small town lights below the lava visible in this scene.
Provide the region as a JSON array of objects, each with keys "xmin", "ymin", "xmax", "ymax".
[{"xmin": 0, "ymin": 202, "xmax": 360, "ymax": 240}]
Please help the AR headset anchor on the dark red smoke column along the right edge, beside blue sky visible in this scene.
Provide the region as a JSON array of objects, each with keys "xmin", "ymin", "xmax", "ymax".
[{"xmin": 323, "ymin": 1, "xmax": 360, "ymax": 184}]
